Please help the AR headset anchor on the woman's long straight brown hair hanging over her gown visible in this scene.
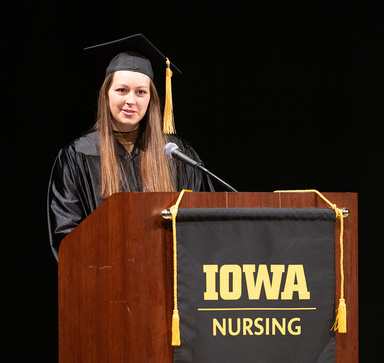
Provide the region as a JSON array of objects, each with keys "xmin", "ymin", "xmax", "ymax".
[{"xmin": 93, "ymin": 73, "xmax": 174, "ymax": 198}]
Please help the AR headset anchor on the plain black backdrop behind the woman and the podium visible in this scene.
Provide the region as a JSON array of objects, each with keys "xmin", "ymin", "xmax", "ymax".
[{"xmin": 0, "ymin": 0, "xmax": 384, "ymax": 362}]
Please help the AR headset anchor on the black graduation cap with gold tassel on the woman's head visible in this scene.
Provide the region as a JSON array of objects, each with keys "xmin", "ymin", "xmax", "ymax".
[{"xmin": 84, "ymin": 33, "xmax": 181, "ymax": 134}]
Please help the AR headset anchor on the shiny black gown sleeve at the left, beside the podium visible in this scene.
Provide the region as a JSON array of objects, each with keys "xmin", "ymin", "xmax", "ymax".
[{"xmin": 47, "ymin": 149, "xmax": 86, "ymax": 260}]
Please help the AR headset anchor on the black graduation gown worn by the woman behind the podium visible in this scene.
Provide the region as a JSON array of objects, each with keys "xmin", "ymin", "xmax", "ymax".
[{"xmin": 48, "ymin": 132, "xmax": 214, "ymax": 259}]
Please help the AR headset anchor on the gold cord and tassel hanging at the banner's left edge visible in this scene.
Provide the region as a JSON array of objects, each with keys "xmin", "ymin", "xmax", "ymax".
[{"xmin": 170, "ymin": 189, "xmax": 192, "ymax": 346}]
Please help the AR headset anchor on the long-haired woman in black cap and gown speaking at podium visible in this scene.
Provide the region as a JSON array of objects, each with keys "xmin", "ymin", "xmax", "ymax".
[{"xmin": 48, "ymin": 34, "xmax": 213, "ymax": 259}]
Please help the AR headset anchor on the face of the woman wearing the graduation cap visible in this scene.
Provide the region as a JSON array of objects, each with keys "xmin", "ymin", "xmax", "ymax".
[{"xmin": 108, "ymin": 71, "xmax": 150, "ymax": 132}]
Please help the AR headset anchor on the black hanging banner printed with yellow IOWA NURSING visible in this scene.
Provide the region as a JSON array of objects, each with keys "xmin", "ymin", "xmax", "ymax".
[{"xmin": 174, "ymin": 208, "xmax": 335, "ymax": 363}]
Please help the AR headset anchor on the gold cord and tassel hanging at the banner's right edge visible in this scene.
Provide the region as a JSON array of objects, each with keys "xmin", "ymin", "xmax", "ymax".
[{"xmin": 274, "ymin": 189, "xmax": 347, "ymax": 333}]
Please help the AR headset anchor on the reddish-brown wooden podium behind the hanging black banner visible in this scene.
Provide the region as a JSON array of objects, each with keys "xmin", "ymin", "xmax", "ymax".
[{"xmin": 58, "ymin": 192, "xmax": 358, "ymax": 363}]
